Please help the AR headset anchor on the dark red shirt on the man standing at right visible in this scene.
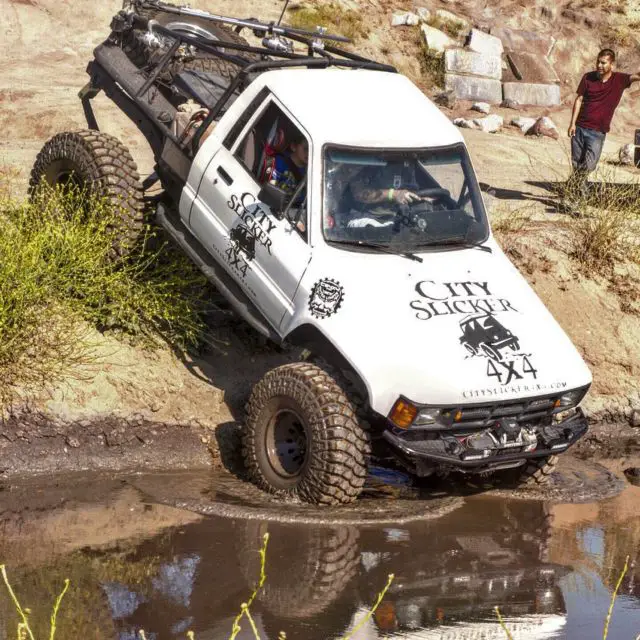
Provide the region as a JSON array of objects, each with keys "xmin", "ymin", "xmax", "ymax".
[{"xmin": 576, "ymin": 71, "xmax": 631, "ymax": 133}]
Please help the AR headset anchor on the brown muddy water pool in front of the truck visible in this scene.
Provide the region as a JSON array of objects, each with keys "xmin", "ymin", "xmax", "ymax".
[{"xmin": 0, "ymin": 462, "xmax": 640, "ymax": 640}]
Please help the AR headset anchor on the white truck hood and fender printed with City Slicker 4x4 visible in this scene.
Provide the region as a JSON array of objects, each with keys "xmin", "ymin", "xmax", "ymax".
[{"xmin": 292, "ymin": 240, "xmax": 591, "ymax": 415}]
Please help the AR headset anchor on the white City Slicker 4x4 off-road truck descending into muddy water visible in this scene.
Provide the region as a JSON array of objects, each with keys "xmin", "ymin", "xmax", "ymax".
[{"xmin": 31, "ymin": 0, "xmax": 591, "ymax": 505}]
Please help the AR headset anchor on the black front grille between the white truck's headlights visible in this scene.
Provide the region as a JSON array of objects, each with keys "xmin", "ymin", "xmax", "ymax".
[{"xmin": 441, "ymin": 397, "xmax": 557, "ymax": 429}]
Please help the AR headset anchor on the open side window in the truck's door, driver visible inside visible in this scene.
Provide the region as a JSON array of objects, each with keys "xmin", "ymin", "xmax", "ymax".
[{"xmin": 234, "ymin": 102, "xmax": 309, "ymax": 239}]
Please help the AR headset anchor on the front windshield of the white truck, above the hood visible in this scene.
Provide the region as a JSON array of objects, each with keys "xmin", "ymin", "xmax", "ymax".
[{"xmin": 323, "ymin": 145, "xmax": 489, "ymax": 251}]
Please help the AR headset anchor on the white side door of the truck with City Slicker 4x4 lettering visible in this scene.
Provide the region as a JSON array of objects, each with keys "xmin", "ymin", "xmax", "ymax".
[{"xmin": 190, "ymin": 95, "xmax": 311, "ymax": 333}]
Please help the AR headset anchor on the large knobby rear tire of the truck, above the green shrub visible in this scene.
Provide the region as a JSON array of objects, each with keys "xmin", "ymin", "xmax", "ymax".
[{"xmin": 29, "ymin": 130, "xmax": 144, "ymax": 256}]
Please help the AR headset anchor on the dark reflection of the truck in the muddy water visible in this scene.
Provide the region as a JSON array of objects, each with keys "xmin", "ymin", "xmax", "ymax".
[{"xmin": 103, "ymin": 499, "xmax": 568, "ymax": 640}]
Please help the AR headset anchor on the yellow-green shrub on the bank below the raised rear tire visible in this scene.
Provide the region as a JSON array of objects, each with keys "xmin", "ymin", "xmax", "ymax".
[{"xmin": 0, "ymin": 185, "xmax": 212, "ymax": 404}]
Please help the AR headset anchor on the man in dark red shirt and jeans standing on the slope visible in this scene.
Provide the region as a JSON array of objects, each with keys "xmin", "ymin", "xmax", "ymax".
[{"xmin": 568, "ymin": 49, "xmax": 640, "ymax": 196}]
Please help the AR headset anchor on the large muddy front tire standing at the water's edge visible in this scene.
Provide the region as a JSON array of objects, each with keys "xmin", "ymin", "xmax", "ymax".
[{"xmin": 242, "ymin": 362, "xmax": 369, "ymax": 505}]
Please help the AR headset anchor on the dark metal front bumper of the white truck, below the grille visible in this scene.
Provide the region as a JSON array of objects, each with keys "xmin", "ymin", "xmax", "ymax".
[{"xmin": 383, "ymin": 409, "xmax": 589, "ymax": 473}]
